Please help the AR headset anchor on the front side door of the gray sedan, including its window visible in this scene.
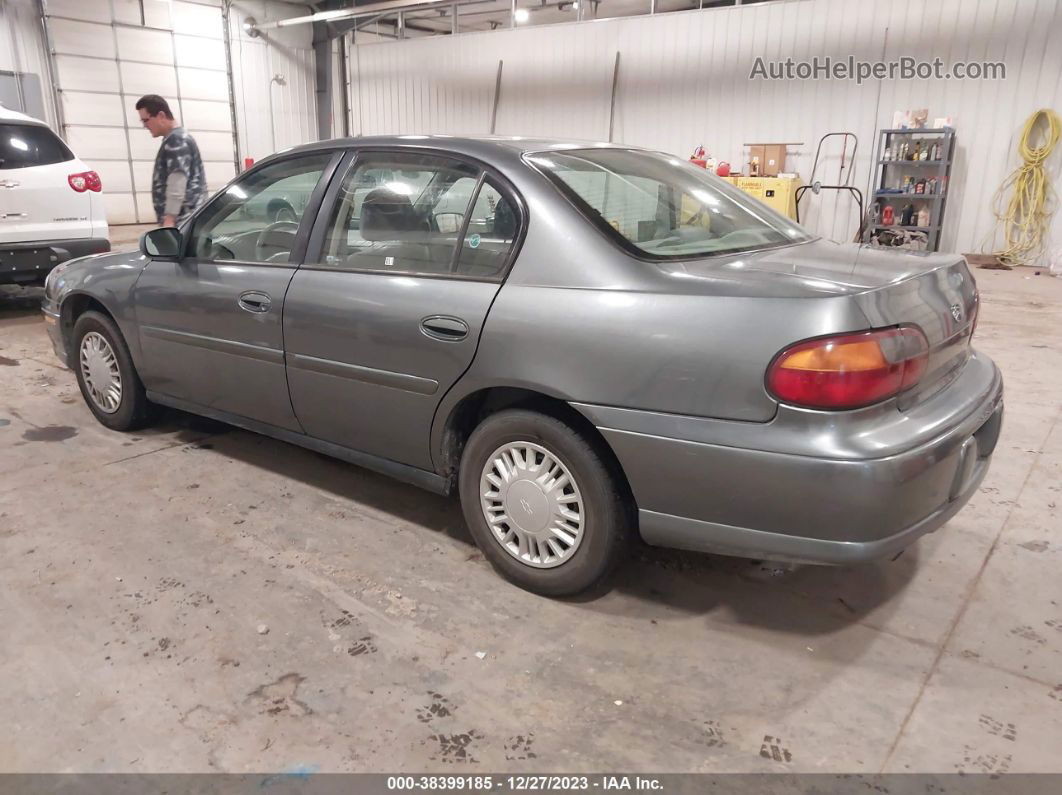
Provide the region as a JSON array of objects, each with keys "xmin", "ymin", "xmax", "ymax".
[{"xmin": 135, "ymin": 152, "xmax": 342, "ymax": 431}]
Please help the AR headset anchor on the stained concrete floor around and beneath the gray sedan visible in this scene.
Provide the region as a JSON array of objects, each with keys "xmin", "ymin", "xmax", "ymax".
[{"xmin": 0, "ymin": 265, "xmax": 1062, "ymax": 773}]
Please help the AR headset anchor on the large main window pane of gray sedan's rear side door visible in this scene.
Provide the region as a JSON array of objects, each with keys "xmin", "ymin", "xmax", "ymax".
[{"xmin": 323, "ymin": 153, "xmax": 479, "ymax": 275}]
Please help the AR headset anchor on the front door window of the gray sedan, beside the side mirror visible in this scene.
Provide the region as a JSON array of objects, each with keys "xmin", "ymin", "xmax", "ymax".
[{"xmin": 189, "ymin": 152, "xmax": 332, "ymax": 263}]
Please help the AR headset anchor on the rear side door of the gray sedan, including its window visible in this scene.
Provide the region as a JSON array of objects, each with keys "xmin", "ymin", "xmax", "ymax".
[{"xmin": 284, "ymin": 151, "xmax": 524, "ymax": 469}]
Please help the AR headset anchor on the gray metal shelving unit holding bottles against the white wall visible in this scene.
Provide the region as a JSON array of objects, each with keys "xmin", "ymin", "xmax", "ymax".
[{"xmin": 864, "ymin": 127, "xmax": 955, "ymax": 252}]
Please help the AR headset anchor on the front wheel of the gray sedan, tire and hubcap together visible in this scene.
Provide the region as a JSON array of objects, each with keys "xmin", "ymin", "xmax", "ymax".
[{"xmin": 73, "ymin": 311, "xmax": 154, "ymax": 431}]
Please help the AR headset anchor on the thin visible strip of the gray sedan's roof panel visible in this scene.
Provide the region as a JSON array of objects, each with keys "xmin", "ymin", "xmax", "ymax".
[{"xmin": 277, "ymin": 135, "xmax": 639, "ymax": 159}]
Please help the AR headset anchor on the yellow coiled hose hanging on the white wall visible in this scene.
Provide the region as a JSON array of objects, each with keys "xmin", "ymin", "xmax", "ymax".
[{"xmin": 992, "ymin": 108, "xmax": 1062, "ymax": 265}]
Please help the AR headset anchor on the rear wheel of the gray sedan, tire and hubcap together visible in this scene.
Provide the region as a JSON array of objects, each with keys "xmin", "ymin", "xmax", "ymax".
[{"xmin": 459, "ymin": 409, "xmax": 631, "ymax": 597}]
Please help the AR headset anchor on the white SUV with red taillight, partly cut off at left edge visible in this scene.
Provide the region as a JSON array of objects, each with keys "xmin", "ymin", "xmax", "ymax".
[{"xmin": 0, "ymin": 105, "xmax": 110, "ymax": 284}]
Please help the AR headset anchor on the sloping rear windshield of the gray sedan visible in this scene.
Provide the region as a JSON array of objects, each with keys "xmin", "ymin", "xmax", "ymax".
[{"xmin": 528, "ymin": 149, "xmax": 812, "ymax": 259}]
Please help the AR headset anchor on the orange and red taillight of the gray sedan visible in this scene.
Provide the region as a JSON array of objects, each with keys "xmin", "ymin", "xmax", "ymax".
[{"xmin": 767, "ymin": 326, "xmax": 929, "ymax": 411}]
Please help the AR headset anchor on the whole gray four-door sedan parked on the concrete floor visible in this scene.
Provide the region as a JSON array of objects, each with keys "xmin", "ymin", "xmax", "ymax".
[{"xmin": 44, "ymin": 136, "xmax": 1003, "ymax": 595}]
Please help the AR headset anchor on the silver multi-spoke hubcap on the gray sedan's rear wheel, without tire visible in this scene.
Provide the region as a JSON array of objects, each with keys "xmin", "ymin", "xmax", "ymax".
[{"xmin": 480, "ymin": 442, "xmax": 585, "ymax": 569}]
